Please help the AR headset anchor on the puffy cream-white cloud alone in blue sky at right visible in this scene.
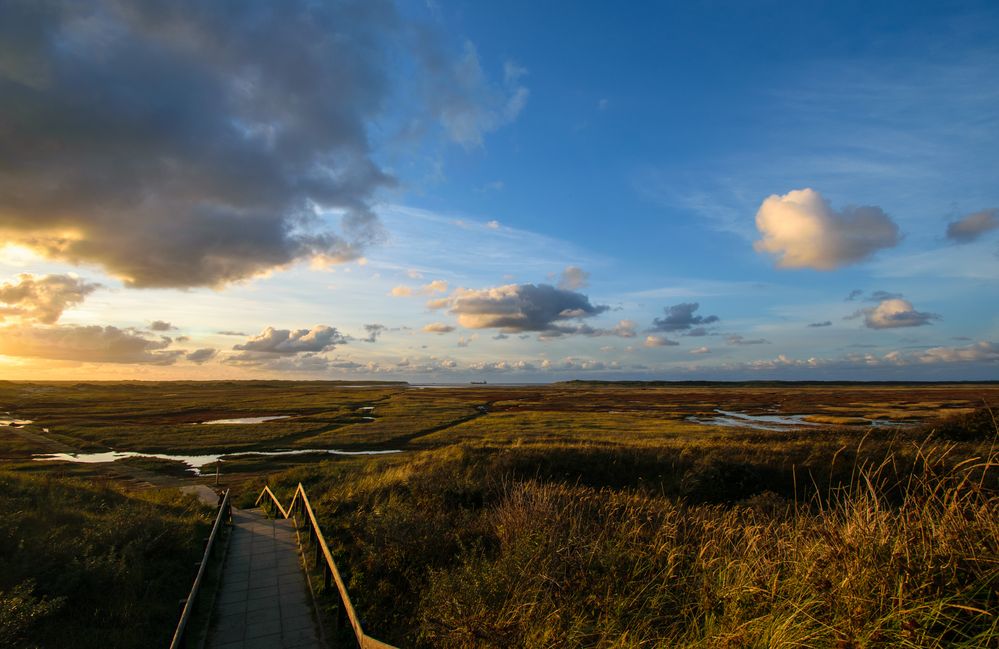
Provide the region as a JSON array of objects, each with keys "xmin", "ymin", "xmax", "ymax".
[{"xmin": 753, "ymin": 189, "xmax": 900, "ymax": 270}]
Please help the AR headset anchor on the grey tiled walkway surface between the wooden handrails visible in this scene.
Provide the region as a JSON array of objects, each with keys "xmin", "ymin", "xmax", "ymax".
[{"xmin": 208, "ymin": 508, "xmax": 324, "ymax": 649}]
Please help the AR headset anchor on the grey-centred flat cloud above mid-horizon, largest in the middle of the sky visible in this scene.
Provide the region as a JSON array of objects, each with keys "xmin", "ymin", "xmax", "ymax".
[{"xmin": 450, "ymin": 284, "xmax": 610, "ymax": 335}]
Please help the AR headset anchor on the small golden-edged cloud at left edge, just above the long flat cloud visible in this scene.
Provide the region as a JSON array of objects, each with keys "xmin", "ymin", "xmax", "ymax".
[{"xmin": 0, "ymin": 274, "xmax": 100, "ymax": 324}]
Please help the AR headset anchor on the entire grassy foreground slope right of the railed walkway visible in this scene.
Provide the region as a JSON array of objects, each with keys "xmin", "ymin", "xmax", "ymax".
[{"xmin": 252, "ymin": 412, "xmax": 999, "ymax": 649}]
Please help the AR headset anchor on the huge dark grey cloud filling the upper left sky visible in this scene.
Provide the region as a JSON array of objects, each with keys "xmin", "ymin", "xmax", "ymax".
[{"xmin": 0, "ymin": 0, "xmax": 528, "ymax": 288}]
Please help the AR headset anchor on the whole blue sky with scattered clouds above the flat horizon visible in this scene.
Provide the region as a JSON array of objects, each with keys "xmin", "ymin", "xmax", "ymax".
[{"xmin": 0, "ymin": 0, "xmax": 999, "ymax": 383}]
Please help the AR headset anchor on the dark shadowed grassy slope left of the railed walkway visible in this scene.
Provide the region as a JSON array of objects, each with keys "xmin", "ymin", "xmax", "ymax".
[{"xmin": 0, "ymin": 471, "xmax": 212, "ymax": 648}]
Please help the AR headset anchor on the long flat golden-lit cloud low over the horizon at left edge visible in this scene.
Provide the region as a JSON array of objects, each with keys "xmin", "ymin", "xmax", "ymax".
[{"xmin": 0, "ymin": 325, "xmax": 184, "ymax": 365}]
